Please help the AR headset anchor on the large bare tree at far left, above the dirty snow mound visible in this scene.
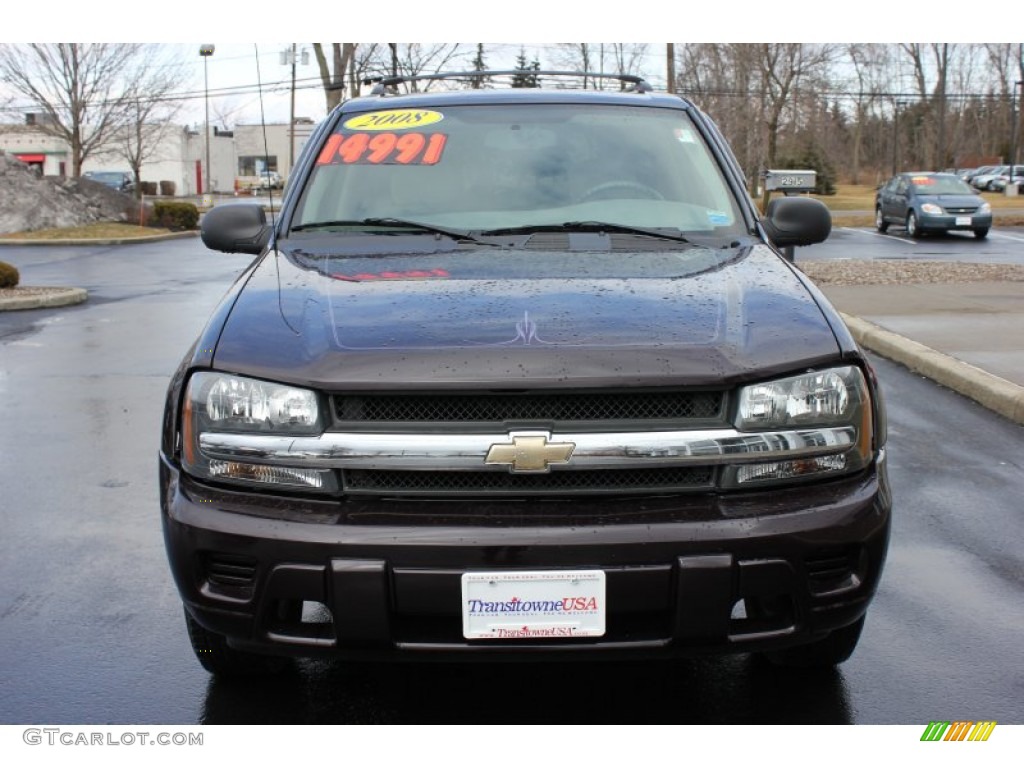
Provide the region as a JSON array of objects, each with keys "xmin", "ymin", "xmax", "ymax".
[{"xmin": 0, "ymin": 43, "xmax": 181, "ymax": 177}]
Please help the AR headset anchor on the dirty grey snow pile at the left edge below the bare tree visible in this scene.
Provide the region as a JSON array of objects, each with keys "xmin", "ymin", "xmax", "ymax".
[{"xmin": 0, "ymin": 152, "xmax": 138, "ymax": 234}]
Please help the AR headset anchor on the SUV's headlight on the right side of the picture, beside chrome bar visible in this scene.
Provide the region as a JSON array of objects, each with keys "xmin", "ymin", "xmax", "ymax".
[{"xmin": 724, "ymin": 366, "xmax": 873, "ymax": 485}]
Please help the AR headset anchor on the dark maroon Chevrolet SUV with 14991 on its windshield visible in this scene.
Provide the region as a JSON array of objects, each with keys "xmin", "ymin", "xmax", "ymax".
[{"xmin": 160, "ymin": 70, "xmax": 891, "ymax": 674}]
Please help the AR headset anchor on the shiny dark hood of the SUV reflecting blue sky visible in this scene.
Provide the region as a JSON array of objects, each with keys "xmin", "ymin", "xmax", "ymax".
[{"xmin": 214, "ymin": 241, "xmax": 840, "ymax": 390}]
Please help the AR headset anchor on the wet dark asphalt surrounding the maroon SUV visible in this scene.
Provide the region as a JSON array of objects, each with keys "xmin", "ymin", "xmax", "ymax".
[{"xmin": 0, "ymin": 241, "xmax": 1024, "ymax": 726}]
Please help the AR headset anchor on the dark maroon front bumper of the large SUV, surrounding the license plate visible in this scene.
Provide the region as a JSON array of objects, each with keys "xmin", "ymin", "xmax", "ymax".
[{"xmin": 161, "ymin": 458, "xmax": 891, "ymax": 659}]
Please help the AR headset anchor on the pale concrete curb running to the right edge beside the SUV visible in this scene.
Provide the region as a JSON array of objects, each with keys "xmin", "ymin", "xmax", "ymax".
[{"xmin": 841, "ymin": 313, "xmax": 1024, "ymax": 424}]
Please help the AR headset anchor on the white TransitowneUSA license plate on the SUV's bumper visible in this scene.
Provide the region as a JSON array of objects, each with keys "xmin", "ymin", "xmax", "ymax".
[{"xmin": 462, "ymin": 570, "xmax": 605, "ymax": 640}]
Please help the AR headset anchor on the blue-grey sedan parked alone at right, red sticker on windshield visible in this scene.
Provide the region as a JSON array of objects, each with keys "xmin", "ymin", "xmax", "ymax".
[{"xmin": 874, "ymin": 173, "xmax": 992, "ymax": 240}]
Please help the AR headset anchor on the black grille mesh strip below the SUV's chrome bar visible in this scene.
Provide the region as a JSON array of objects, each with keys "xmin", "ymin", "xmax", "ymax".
[{"xmin": 343, "ymin": 467, "xmax": 714, "ymax": 496}]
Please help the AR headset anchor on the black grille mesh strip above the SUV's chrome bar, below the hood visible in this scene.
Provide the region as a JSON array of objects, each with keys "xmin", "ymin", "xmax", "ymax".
[{"xmin": 334, "ymin": 392, "xmax": 723, "ymax": 424}]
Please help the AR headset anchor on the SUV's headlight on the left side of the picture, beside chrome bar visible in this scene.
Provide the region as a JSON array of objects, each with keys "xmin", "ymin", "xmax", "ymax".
[{"xmin": 181, "ymin": 372, "xmax": 337, "ymax": 492}]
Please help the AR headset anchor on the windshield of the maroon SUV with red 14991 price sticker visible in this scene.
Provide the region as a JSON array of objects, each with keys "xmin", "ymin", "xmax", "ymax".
[{"xmin": 291, "ymin": 104, "xmax": 743, "ymax": 236}]
